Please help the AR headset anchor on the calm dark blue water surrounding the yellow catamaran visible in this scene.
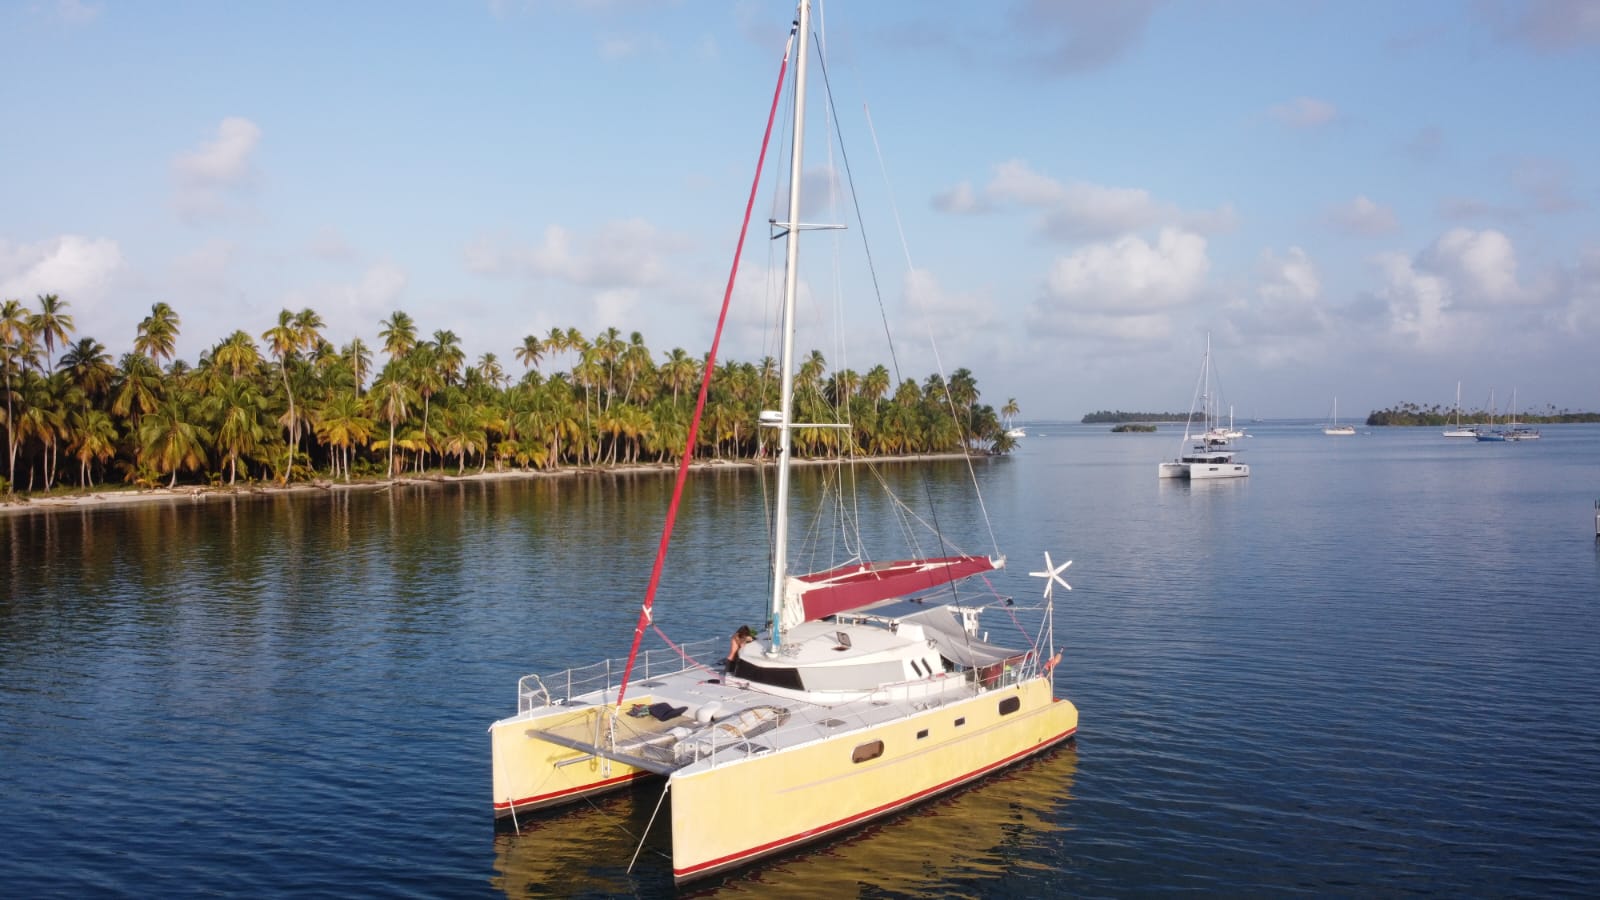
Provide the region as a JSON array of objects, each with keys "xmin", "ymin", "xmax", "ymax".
[{"xmin": 0, "ymin": 426, "xmax": 1600, "ymax": 897}]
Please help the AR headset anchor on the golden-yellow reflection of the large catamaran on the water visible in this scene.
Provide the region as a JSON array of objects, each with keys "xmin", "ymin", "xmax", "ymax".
[{"xmin": 491, "ymin": 741, "xmax": 1078, "ymax": 897}]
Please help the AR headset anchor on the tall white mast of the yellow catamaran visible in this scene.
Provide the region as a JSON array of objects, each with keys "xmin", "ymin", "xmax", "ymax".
[{"xmin": 770, "ymin": 0, "xmax": 811, "ymax": 652}]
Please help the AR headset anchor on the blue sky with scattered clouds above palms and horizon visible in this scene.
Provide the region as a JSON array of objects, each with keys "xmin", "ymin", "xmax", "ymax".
[{"xmin": 0, "ymin": 0, "xmax": 1600, "ymax": 418}]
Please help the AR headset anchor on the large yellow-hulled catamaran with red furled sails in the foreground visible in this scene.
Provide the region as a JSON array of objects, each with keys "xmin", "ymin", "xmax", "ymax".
[{"xmin": 490, "ymin": 0, "xmax": 1078, "ymax": 882}]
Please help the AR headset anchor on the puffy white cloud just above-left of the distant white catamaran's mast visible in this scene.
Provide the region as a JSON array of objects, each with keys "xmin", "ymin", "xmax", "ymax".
[{"xmin": 1040, "ymin": 227, "xmax": 1211, "ymax": 315}]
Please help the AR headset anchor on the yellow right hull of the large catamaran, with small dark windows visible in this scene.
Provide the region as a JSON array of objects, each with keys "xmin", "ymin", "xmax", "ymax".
[{"xmin": 667, "ymin": 676, "xmax": 1078, "ymax": 882}]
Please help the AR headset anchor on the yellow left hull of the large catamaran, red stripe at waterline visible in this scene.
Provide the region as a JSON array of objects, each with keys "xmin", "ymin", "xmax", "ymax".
[{"xmin": 490, "ymin": 706, "xmax": 651, "ymax": 818}]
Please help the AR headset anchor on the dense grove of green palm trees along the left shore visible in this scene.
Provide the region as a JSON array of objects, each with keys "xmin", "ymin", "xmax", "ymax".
[{"xmin": 0, "ymin": 298, "xmax": 1016, "ymax": 488}]
